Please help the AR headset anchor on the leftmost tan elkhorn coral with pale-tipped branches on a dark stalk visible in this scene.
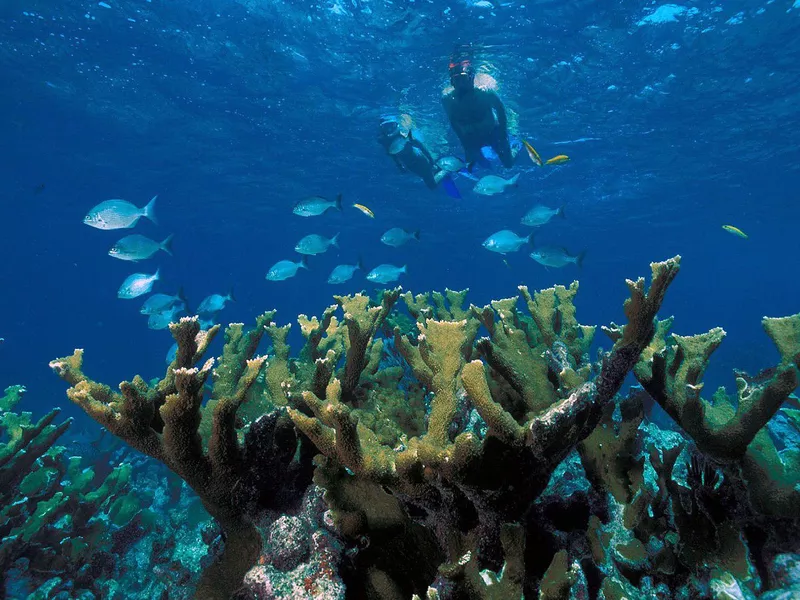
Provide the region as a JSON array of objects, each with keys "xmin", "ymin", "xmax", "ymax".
[{"xmin": 50, "ymin": 318, "xmax": 310, "ymax": 599}]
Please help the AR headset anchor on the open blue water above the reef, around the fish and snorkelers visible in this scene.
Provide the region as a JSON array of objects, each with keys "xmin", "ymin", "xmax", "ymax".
[{"xmin": 0, "ymin": 0, "xmax": 800, "ymax": 426}]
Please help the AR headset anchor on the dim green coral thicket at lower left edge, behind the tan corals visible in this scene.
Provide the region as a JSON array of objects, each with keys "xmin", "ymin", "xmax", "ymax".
[{"xmin": 0, "ymin": 386, "xmax": 164, "ymax": 599}]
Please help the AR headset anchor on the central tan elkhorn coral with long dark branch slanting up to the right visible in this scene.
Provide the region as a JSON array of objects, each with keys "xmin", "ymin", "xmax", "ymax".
[{"xmin": 289, "ymin": 259, "xmax": 678, "ymax": 597}]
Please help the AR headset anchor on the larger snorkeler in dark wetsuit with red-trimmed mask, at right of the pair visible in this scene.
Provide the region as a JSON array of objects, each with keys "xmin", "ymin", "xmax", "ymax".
[{"xmin": 442, "ymin": 59, "xmax": 514, "ymax": 168}]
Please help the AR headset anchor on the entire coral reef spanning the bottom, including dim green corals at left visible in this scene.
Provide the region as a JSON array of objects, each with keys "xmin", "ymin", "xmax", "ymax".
[{"xmin": 0, "ymin": 257, "xmax": 800, "ymax": 600}]
